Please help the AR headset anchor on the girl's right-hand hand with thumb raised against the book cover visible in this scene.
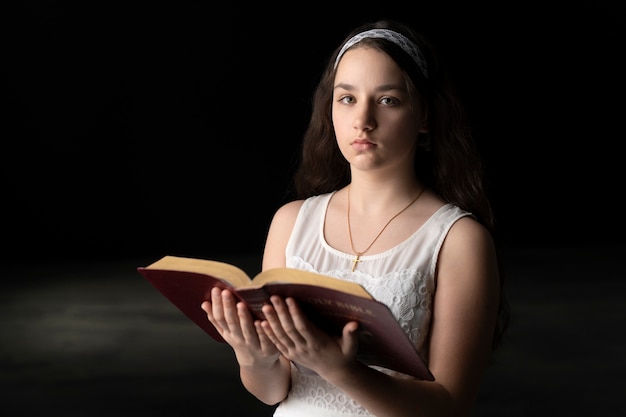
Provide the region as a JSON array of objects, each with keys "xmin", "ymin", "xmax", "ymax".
[{"xmin": 261, "ymin": 296, "xmax": 358, "ymax": 375}]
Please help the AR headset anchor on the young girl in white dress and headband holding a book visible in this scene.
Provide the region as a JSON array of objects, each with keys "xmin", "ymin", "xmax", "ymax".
[{"xmin": 202, "ymin": 17, "xmax": 505, "ymax": 417}]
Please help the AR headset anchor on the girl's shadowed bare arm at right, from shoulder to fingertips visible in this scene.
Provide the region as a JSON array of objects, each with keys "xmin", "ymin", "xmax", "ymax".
[{"xmin": 263, "ymin": 218, "xmax": 499, "ymax": 417}]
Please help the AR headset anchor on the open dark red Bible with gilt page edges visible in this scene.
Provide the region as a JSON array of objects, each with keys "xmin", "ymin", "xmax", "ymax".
[{"xmin": 137, "ymin": 256, "xmax": 434, "ymax": 381}]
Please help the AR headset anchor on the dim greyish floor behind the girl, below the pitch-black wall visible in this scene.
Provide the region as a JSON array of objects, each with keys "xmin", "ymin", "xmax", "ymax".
[{"xmin": 0, "ymin": 247, "xmax": 626, "ymax": 417}]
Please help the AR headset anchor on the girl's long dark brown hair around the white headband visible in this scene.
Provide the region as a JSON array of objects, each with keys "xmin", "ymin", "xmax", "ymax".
[{"xmin": 294, "ymin": 20, "xmax": 509, "ymax": 352}]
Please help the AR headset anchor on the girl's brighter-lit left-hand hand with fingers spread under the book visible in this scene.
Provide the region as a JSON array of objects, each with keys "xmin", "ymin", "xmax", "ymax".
[{"xmin": 202, "ymin": 288, "xmax": 280, "ymax": 366}]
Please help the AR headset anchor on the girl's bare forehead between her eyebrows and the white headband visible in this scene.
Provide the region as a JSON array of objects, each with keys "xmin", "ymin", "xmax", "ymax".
[{"xmin": 335, "ymin": 45, "xmax": 403, "ymax": 82}]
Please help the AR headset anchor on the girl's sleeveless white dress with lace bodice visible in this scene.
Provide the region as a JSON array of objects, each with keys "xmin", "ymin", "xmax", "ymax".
[{"xmin": 274, "ymin": 193, "xmax": 471, "ymax": 417}]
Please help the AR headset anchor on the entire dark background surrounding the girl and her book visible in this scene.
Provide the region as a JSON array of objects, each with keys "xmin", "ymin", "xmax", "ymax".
[{"xmin": 0, "ymin": 1, "xmax": 626, "ymax": 417}]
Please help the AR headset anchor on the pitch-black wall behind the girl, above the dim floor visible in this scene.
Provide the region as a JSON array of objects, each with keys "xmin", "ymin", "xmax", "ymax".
[{"xmin": 0, "ymin": 1, "xmax": 625, "ymax": 259}]
